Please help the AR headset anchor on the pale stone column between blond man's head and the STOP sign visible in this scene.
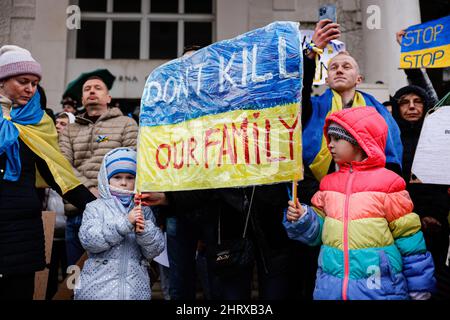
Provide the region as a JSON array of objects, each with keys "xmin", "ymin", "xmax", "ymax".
[{"xmin": 361, "ymin": 0, "xmax": 421, "ymax": 95}]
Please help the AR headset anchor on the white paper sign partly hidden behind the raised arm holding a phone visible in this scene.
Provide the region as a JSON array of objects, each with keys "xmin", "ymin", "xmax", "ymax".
[{"xmin": 300, "ymin": 30, "xmax": 345, "ymax": 85}]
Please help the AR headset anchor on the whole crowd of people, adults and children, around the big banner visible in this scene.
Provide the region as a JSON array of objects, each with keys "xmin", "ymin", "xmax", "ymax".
[{"xmin": 0, "ymin": 20, "xmax": 450, "ymax": 300}]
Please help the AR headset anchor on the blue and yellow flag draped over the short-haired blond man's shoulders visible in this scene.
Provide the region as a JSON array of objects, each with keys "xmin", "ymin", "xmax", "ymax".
[{"xmin": 303, "ymin": 89, "xmax": 403, "ymax": 181}]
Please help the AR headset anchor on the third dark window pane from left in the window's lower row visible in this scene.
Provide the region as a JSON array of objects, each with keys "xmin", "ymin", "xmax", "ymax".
[{"xmin": 150, "ymin": 22, "xmax": 178, "ymax": 59}]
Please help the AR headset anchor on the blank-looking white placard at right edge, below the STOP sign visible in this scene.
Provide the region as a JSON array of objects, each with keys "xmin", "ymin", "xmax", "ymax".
[{"xmin": 411, "ymin": 106, "xmax": 450, "ymax": 185}]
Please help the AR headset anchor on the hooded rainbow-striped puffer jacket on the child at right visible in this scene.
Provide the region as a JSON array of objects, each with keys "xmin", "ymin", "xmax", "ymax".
[{"xmin": 284, "ymin": 107, "xmax": 435, "ymax": 300}]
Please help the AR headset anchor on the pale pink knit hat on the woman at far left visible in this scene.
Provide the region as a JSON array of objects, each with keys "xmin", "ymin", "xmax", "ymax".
[{"xmin": 0, "ymin": 45, "xmax": 42, "ymax": 80}]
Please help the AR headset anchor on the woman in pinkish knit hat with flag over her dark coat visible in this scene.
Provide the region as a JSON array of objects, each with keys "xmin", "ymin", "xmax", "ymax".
[{"xmin": 0, "ymin": 45, "xmax": 95, "ymax": 300}]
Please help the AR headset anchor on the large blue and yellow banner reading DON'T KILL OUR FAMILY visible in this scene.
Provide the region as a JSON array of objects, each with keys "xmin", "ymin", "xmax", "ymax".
[{"xmin": 136, "ymin": 22, "xmax": 303, "ymax": 192}]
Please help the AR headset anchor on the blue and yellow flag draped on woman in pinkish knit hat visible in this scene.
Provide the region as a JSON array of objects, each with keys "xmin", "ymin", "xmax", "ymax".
[{"xmin": 0, "ymin": 92, "xmax": 81, "ymax": 194}]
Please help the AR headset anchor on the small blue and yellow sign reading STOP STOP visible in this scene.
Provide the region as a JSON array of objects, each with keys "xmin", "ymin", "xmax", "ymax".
[{"xmin": 400, "ymin": 16, "xmax": 450, "ymax": 69}]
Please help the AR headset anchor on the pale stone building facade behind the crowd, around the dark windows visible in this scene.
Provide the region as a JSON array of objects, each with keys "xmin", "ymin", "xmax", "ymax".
[{"xmin": 0, "ymin": 0, "xmax": 442, "ymax": 111}]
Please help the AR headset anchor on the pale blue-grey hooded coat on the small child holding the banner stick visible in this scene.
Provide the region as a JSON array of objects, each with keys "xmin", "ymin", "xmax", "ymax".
[{"xmin": 75, "ymin": 149, "xmax": 164, "ymax": 300}]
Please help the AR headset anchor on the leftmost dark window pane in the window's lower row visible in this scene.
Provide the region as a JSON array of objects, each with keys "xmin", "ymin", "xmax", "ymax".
[{"xmin": 77, "ymin": 20, "xmax": 106, "ymax": 59}]
